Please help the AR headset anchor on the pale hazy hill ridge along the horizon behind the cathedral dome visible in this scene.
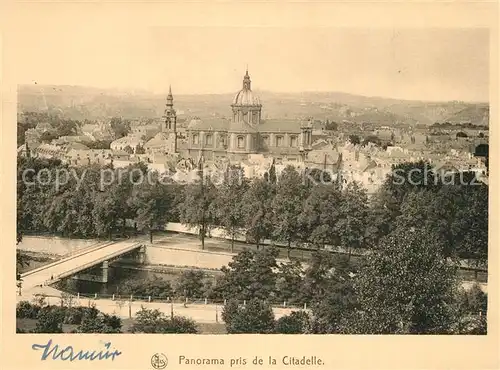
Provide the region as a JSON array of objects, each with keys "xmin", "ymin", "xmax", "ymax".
[{"xmin": 18, "ymin": 85, "xmax": 489, "ymax": 125}]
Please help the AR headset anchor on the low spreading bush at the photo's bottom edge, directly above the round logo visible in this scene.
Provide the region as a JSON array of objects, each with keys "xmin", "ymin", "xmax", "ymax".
[{"xmin": 130, "ymin": 307, "xmax": 198, "ymax": 334}]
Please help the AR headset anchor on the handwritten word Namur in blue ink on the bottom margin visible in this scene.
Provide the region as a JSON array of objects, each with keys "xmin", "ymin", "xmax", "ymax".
[{"xmin": 31, "ymin": 339, "xmax": 122, "ymax": 361}]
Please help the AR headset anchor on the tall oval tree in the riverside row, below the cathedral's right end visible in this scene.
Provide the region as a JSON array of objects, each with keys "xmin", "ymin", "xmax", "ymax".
[{"xmin": 271, "ymin": 166, "xmax": 305, "ymax": 258}]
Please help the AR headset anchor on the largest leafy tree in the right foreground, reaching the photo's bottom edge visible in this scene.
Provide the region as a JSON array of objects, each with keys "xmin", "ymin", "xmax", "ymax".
[{"xmin": 349, "ymin": 227, "xmax": 458, "ymax": 334}]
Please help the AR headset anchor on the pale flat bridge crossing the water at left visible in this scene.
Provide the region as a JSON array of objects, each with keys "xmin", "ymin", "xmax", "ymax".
[{"xmin": 21, "ymin": 240, "xmax": 145, "ymax": 292}]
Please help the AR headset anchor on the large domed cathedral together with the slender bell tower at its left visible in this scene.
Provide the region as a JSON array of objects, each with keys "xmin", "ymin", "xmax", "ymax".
[{"xmin": 160, "ymin": 70, "xmax": 312, "ymax": 162}]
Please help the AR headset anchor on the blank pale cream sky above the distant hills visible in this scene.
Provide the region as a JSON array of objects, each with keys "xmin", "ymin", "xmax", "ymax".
[{"xmin": 10, "ymin": 26, "xmax": 490, "ymax": 101}]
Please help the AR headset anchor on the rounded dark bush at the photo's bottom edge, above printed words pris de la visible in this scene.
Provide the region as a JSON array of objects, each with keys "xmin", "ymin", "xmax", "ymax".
[{"xmin": 222, "ymin": 299, "xmax": 274, "ymax": 334}]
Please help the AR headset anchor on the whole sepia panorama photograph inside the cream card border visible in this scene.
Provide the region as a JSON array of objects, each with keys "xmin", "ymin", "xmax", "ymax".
[{"xmin": 15, "ymin": 27, "xmax": 490, "ymax": 338}]
